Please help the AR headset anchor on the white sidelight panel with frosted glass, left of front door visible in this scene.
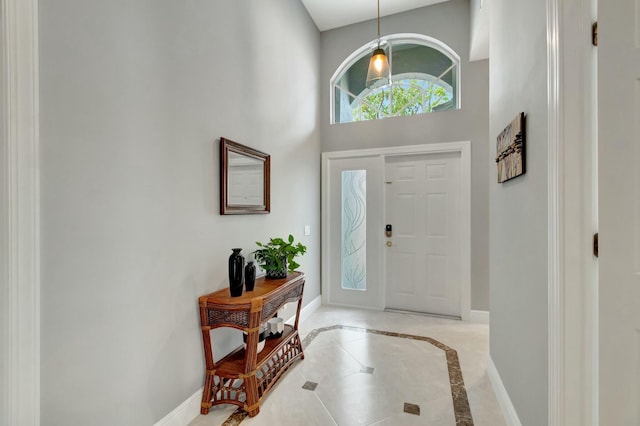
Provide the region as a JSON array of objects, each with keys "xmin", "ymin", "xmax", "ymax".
[{"xmin": 324, "ymin": 156, "xmax": 384, "ymax": 309}]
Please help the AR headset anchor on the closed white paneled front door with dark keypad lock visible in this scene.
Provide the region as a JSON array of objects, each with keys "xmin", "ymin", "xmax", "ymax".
[{"xmin": 385, "ymin": 152, "xmax": 462, "ymax": 317}]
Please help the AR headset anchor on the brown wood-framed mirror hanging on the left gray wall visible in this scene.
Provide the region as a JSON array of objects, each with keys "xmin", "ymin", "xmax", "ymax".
[{"xmin": 220, "ymin": 138, "xmax": 271, "ymax": 214}]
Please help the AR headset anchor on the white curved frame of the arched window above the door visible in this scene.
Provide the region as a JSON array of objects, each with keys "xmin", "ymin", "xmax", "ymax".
[{"xmin": 329, "ymin": 33, "xmax": 462, "ymax": 124}]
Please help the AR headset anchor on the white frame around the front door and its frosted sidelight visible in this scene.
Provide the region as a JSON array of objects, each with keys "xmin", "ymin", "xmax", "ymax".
[{"xmin": 321, "ymin": 141, "xmax": 471, "ymax": 321}]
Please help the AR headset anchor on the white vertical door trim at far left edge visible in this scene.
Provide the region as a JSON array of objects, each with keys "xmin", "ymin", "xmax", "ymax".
[{"xmin": 0, "ymin": 0, "xmax": 40, "ymax": 426}]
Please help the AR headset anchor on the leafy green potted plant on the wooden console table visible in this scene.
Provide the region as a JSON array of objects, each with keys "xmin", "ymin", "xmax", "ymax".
[{"xmin": 253, "ymin": 235, "xmax": 307, "ymax": 278}]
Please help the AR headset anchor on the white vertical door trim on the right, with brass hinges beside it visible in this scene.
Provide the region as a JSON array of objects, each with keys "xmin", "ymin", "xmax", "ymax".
[{"xmin": 547, "ymin": 0, "xmax": 598, "ymax": 426}]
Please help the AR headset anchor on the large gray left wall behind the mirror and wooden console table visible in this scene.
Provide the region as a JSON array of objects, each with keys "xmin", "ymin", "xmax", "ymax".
[{"xmin": 40, "ymin": 0, "xmax": 324, "ymax": 425}]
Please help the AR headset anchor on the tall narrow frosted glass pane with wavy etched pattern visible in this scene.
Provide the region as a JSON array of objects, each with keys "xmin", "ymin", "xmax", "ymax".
[{"xmin": 341, "ymin": 170, "xmax": 367, "ymax": 290}]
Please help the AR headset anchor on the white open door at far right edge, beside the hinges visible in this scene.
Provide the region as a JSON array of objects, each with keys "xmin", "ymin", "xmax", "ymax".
[{"xmin": 598, "ymin": 0, "xmax": 640, "ymax": 426}]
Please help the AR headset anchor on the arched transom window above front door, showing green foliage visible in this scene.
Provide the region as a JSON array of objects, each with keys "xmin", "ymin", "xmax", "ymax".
[{"xmin": 331, "ymin": 34, "xmax": 460, "ymax": 123}]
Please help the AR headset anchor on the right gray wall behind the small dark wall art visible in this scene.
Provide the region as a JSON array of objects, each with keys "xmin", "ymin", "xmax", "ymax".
[{"xmin": 487, "ymin": 0, "xmax": 548, "ymax": 426}]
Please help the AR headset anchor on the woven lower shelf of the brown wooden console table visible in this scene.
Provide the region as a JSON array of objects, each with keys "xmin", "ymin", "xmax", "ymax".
[{"xmin": 201, "ymin": 325, "xmax": 304, "ymax": 416}]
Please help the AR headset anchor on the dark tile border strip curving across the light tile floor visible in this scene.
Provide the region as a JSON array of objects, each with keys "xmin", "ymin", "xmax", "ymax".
[{"xmin": 222, "ymin": 324, "xmax": 474, "ymax": 426}]
